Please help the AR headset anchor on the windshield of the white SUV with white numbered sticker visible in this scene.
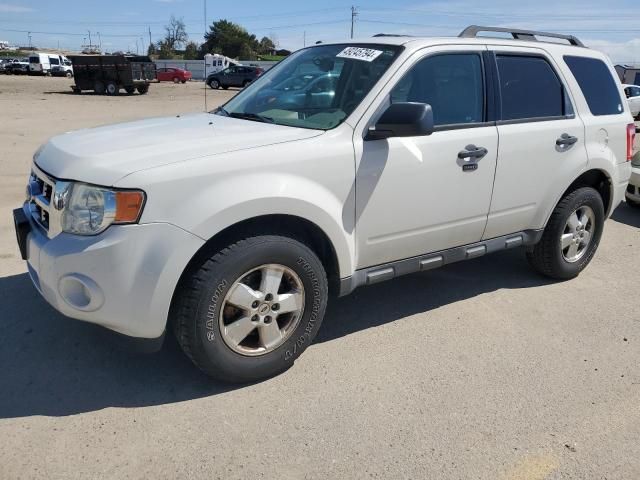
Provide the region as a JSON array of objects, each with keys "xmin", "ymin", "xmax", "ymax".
[{"xmin": 216, "ymin": 44, "xmax": 402, "ymax": 130}]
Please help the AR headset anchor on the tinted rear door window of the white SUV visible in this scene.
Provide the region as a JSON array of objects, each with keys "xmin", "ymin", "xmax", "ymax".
[{"xmin": 496, "ymin": 54, "xmax": 568, "ymax": 120}]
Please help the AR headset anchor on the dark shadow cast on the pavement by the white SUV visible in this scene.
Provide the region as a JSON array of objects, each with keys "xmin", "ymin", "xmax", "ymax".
[{"xmin": 0, "ymin": 246, "xmax": 548, "ymax": 418}]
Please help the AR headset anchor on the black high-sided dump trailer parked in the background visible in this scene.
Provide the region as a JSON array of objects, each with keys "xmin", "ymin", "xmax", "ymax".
[{"xmin": 69, "ymin": 55, "xmax": 157, "ymax": 95}]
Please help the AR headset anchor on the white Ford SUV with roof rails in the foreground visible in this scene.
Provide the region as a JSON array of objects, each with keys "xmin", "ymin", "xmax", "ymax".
[{"xmin": 14, "ymin": 27, "xmax": 635, "ymax": 381}]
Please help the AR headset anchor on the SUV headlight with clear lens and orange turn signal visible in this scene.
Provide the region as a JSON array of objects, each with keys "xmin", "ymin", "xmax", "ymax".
[{"xmin": 62, "ymin": 182, "xmax": 145, "ymax": 235}]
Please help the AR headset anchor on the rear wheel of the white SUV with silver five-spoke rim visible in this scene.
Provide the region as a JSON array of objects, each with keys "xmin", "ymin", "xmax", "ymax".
[{"xmin": 527, "ymin": 187, "xmax": 605, "ymax": 280}]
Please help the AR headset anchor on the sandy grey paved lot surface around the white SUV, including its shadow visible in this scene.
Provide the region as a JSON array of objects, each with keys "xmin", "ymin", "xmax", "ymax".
[{"xmin": 0, "ymin": 77, "xmax": 640, "ymax": 480}]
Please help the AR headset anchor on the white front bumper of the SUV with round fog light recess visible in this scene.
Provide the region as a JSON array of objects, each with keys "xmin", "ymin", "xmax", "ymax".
[{"xmin": 15, "ymin": 204, "xmax": 204, "ymax": 338}]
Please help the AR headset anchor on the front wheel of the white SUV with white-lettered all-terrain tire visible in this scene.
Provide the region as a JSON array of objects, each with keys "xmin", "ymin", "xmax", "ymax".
[{"xmin": 172, "ymin": 236, "xmax": 328, "ymax": 382}]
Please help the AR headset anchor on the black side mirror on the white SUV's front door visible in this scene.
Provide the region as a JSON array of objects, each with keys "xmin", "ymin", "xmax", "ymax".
[{"xmin": 364, "ymin": 102, "xmax": 435, "ymax": 140}]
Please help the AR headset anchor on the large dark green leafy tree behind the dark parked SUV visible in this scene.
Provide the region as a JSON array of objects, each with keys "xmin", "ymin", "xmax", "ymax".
[{"xmin": 200, "ymin": 20, "xmax": 260, "ymax": 60}]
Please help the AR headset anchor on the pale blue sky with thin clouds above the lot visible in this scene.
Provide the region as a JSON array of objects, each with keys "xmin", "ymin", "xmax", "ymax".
[{"xmin": 0, "ymin": 0, "xmax": 640, "ymax": 63}]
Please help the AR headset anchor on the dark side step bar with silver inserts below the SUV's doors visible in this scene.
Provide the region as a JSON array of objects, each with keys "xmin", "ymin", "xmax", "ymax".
[{"xmin": 340, "ymin": 230, "xmax": 543, "ymax": 297}]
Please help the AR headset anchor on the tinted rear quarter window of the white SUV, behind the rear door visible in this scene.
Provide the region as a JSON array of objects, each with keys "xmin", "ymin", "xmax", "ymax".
[{"xmin": 564, "ymin": 55, "xmax": 624, "ymax": 116}]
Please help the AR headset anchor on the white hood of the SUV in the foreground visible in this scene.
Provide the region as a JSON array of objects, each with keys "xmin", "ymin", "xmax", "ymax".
[{"xmin": 36, "ymin": 113, "xmax": 324, "ymax": 186}]
